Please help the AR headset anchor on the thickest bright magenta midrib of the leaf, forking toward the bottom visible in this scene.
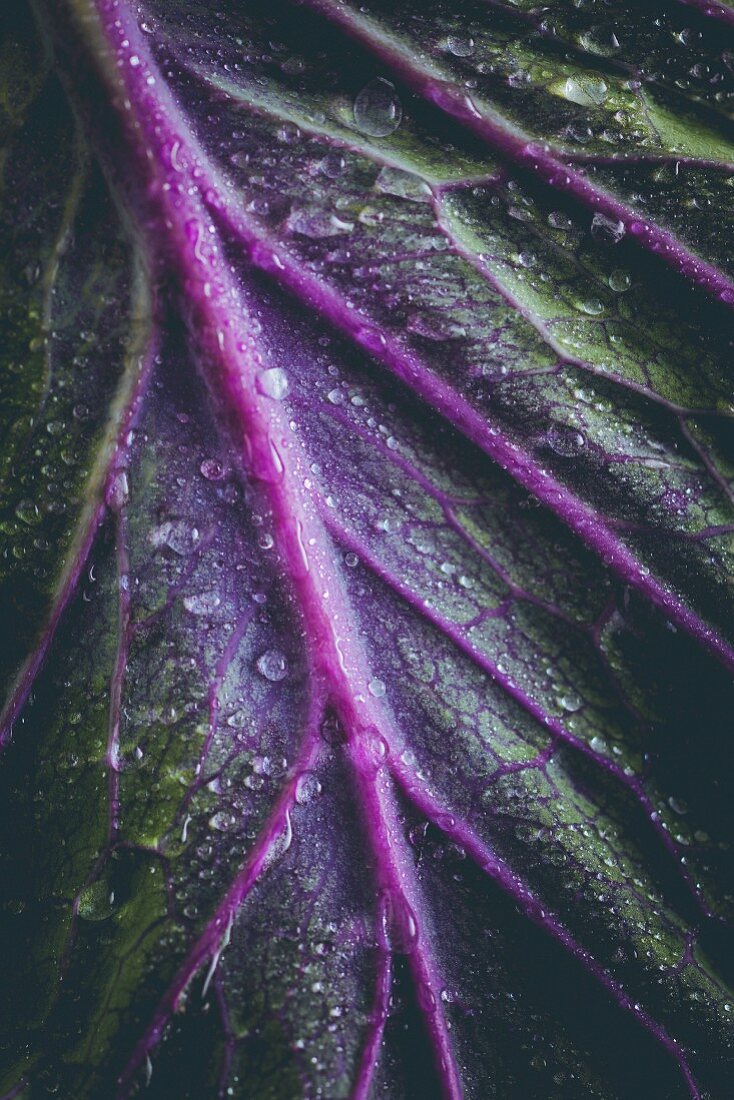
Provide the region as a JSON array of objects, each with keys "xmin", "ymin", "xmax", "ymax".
[{"xmin": 89, "ymin": 0, "xmax": 461, "ymax": 1100}]
